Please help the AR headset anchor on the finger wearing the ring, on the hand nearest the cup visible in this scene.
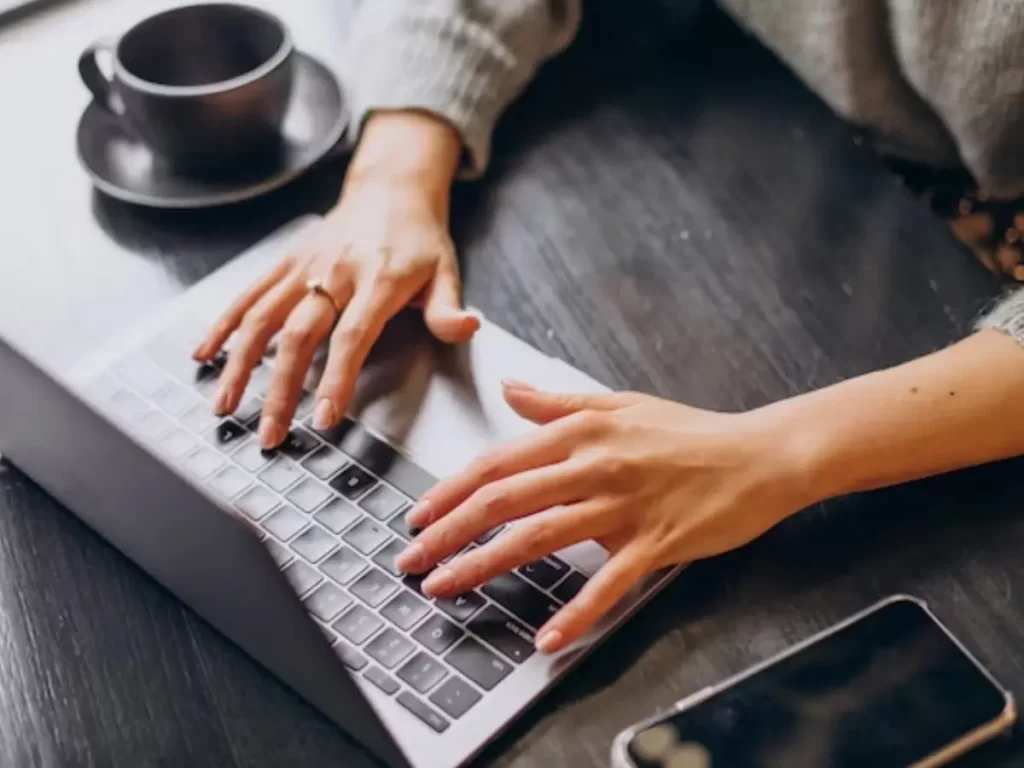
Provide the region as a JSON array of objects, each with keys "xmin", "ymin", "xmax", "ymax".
[{"xmin": 259, "ymin": 293, "xmax": 335, "ymax": 450}]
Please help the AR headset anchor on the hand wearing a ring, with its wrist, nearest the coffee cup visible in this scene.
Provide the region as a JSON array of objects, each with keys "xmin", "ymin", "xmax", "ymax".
[{"xmin": 195, "ymin": 113, "xmax": 479, "ymax": 447}]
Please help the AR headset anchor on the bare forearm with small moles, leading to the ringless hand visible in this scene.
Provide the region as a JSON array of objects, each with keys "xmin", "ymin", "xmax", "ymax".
[{"xmin": 762, "ymin": 331, "xmax": 1024, "ymax": 501}]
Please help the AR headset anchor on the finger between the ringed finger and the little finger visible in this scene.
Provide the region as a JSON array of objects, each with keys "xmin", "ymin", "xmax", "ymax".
[{"xmin": 213, "ymin": 272, "xmax": 305, "ymax": 416}]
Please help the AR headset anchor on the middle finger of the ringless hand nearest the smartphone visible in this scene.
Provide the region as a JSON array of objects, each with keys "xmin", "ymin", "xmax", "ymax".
[{"xmin": 395, "ymin": 462, "xmax": 593, "ymax": 573}]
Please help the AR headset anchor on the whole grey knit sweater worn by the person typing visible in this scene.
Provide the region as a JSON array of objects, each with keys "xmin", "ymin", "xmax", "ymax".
[{"xmin": 342, "ymin": 0, "xmax": 1024, "ymax": 345}]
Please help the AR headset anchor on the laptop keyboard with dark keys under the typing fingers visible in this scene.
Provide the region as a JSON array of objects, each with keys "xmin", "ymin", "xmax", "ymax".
[{"xmin": 81, "ymin": 321, "xmax": 586, "ymax": 733}]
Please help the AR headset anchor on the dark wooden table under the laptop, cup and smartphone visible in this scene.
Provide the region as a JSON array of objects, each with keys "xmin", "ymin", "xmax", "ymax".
[{"xmin": 0, "ymin": 0, "xmax": 1024, "ymax": 768}]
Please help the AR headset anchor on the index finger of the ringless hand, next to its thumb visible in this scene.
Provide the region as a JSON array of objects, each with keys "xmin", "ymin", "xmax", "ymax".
[{"xmin": 406, "ymin": 417, "xmax": 587, "ymax": 528}]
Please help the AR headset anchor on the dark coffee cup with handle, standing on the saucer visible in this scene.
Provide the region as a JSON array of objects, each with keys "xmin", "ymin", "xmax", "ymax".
[{"xmin": 79, "ymin": 3, "xmax": 295, "ymax": 175}]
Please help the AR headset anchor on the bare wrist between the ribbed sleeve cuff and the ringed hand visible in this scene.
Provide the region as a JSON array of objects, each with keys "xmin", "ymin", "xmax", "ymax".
[{"xmin": 345, "ymin": 111, "xmax": 462, "ymax": 201}]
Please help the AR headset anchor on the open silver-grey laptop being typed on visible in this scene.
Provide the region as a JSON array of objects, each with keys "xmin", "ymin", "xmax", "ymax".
[{"xmin": 0, "ymin": 217, "xmax": 675, "ymax": 768}]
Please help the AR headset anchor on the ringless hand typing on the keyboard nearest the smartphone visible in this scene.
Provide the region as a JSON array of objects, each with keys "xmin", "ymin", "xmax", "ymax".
[{"xmin": 397, "ymin": 383, "xmax": 813, "ymax": 652}]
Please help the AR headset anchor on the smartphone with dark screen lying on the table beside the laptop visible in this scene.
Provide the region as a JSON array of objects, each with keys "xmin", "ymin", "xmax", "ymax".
[{"xmin": 612, "ymin": 595, "xmax": 1016, "ymax": 768}]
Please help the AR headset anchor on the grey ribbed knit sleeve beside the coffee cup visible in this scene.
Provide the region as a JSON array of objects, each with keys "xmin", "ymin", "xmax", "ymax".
[{"xmin": 342, "ymin": 0, "xmax": 581, "ymax": 176}]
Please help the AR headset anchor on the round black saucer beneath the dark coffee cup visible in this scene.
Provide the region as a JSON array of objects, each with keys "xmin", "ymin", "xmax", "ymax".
[{"xmin": 78, "ymin": 53, "xmax": 348, "ymax": 208}]
